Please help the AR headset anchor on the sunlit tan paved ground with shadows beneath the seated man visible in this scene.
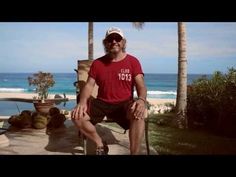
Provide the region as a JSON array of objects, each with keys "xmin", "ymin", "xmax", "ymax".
[{"xmin": 0, "ymin": 119, "xmax": 158, "ymax": 155}]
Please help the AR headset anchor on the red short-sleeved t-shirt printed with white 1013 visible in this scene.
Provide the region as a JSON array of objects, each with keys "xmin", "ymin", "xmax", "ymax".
[{"xmin": 88, "ymin": 54, "xmax": 143, "ymax": 104}]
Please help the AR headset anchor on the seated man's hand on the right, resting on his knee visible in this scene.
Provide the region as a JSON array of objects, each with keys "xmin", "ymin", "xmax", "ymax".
[{"xmin": 131, "ymin": 99, "xmax": 146, "ymax": 119}]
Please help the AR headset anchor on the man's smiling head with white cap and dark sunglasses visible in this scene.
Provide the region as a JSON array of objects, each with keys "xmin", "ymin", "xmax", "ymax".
[{"xmin": 103, "ymin": 27, "xmax": 126, "ymax": 53}]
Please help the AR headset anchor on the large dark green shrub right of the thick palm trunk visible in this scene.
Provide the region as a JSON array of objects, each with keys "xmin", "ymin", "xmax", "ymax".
[{"xmin": 187, "ymin": 68, "xmax": 236, "ymax": 135}]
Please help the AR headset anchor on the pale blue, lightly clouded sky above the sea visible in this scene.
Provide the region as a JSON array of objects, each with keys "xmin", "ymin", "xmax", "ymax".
[{"xmin": 0, "ymin": 22, "xmax": 236, "ymax": 74}]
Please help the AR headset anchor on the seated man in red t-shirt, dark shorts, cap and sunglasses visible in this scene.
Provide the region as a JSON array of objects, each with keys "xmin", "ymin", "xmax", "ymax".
[{"xmin": 72, "ymin": 27, "xmax": 147, "ymax": 155}]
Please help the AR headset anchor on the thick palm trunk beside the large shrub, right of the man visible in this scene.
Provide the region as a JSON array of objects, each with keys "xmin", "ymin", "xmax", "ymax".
[{"xmin": 176, "ymin": 22, "xmax": 188, "ymax": 128}]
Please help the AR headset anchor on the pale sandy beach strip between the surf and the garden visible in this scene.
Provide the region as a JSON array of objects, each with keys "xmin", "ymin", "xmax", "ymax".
[{"xmin": 0, "ymin": 92, "xmax": 175, "ymax": 118}]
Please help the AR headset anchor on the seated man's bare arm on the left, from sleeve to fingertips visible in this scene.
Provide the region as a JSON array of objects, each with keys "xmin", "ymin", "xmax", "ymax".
[{"xmin": 71, "ymin": 77, "xmax": 95, "ymax": 119}]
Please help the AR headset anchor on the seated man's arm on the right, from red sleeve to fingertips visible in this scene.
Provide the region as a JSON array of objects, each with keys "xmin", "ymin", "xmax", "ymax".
[{"xmin": 131, "ymin": 74, "xmax": 147, "ymax": 119}]
